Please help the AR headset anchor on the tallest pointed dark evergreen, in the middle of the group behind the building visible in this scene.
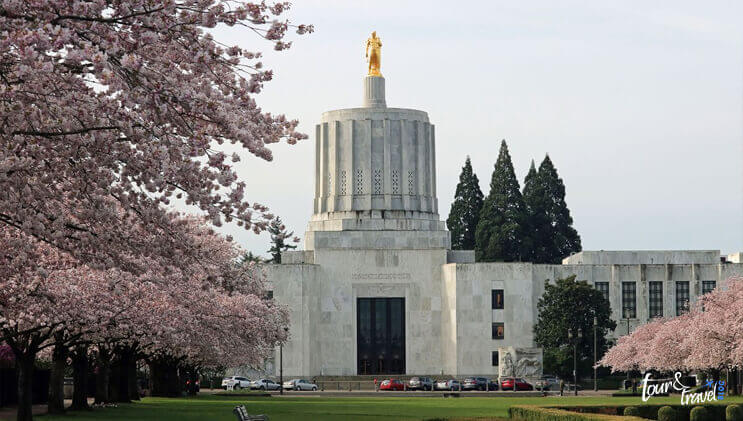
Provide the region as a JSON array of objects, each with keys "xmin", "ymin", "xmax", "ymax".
[{"xmin": 475, "ymin": 140, "xmax": 525, "ymax": 262}]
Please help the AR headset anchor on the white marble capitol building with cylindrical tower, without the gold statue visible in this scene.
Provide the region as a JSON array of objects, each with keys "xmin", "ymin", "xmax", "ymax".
[{"xmin": 266, "ymin": 72, "xmax": 743, "ymax": 377}]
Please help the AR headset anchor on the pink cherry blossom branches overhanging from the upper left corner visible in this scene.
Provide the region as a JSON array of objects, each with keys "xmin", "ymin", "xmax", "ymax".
[{"xmin": 0, "ymin": 0, "xmax": 312, "ymax": 266}]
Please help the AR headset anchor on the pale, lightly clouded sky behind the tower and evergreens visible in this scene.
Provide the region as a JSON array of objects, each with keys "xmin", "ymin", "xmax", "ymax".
[{"xmin": 206, "ymin": 0, "xmax": 743, "ymax": 255}]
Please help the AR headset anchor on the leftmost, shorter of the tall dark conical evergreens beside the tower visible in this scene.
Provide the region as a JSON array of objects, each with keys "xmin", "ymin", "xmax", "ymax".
[{"xmin": 446, "ymin": 156, "xmax": 483, "ymax": 250}]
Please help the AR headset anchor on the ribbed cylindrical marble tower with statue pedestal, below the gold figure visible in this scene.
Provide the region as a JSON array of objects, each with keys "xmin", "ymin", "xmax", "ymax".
[{"xmin": 309, "ymin": 76, "xmax": 445, "ymax": 231}]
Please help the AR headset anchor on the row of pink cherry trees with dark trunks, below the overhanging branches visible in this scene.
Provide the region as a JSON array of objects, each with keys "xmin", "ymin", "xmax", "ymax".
[{"xmin": 0, "ymin": 214, "xmax": 288, "ymax": 419}]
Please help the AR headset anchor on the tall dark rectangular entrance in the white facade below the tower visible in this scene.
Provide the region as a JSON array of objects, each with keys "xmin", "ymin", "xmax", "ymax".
[{"xmin": 356, "ymin": 298, "xmax": 405, "ymax": 374}]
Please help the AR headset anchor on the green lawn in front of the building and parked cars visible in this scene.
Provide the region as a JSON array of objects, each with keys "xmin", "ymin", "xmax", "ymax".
[{"xmin": 33, "ymin": 395, "xmax": 743, "ymax": 421}]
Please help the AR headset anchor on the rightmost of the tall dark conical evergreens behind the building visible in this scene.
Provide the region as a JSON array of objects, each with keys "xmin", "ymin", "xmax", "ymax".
[{"xmin": 537, "ymin": 155, "xmax": 581, "ymax": 263}]
